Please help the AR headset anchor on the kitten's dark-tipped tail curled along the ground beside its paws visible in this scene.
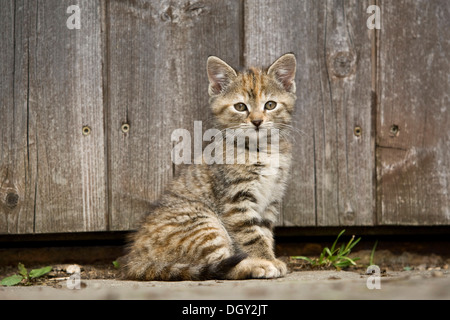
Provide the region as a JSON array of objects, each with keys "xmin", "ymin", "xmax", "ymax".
[{"xmin": 122, "ymin": 253, "xmax": 247, "ymax": 281}]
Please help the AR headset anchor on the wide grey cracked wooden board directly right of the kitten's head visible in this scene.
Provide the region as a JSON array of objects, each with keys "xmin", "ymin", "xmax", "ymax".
[{"xmin": 244, "ymin": 0, "xmax": 375, "ymax": 226}]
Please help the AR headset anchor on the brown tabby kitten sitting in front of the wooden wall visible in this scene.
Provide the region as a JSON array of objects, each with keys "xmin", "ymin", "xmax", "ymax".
[{"xmin": 122, "ymin": 54, "xmax": 296, "ymax": 280}]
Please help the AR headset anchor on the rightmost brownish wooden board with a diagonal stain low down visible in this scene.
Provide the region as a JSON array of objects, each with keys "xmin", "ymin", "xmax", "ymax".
[{"xmin": 377, "ymin": 0, "xmax": 450, "ymax": 225}]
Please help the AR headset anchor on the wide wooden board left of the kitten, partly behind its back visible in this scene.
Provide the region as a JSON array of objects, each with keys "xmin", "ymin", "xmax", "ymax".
[{"xmin": 107, "ymin": 0, "xmax": 241, "ymax": 230}]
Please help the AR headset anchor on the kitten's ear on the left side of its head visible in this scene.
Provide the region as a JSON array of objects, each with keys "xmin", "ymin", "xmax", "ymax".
[{"xmin": 206, "ymin": 56, "xmax": 237, "ymax": 96}]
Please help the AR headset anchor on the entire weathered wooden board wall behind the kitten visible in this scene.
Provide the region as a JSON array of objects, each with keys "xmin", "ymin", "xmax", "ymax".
[{"xmin": 0, "ymin": 0, "xmax": 450, "ymax": 234}]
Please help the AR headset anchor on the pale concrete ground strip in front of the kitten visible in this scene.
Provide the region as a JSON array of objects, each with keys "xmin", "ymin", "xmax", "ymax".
[{"xmin": 0, "ymin": 270, "xmax": 450, "ymax": 300}]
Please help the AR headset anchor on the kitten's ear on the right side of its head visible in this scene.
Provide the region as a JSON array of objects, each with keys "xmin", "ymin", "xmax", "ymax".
[{"xmin": 267, "ymin": 53, "xmax": 297, "ymax": 93}]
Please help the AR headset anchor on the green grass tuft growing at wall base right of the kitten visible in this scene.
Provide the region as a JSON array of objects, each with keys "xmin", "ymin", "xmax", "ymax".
[{"xmin": 291, "ymin": 230, "xmax": 361, "ymax": 270}]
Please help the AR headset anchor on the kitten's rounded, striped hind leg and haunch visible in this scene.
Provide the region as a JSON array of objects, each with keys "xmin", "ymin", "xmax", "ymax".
[{"xmin": 121, "ymin": 205, "xmax": 234, "ymax": 280}]
